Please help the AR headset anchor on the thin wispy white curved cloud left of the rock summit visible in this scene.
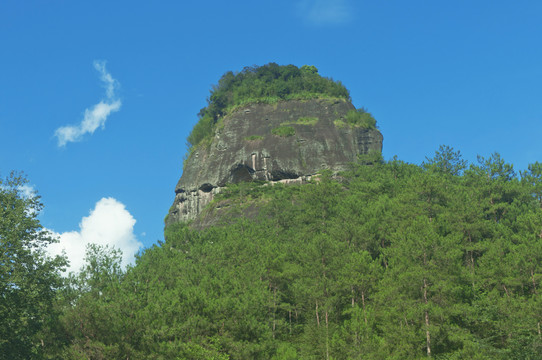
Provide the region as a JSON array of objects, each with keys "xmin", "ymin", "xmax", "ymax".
[{"xmin": 55, "ymin": 61, "xmax": 122, "ymax": 147}]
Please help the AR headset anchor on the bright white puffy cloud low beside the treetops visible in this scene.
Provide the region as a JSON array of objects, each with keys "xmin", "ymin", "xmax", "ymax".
[{"xmin": 47, "ymin": 198, "xmax": 142, "ymax": 272}]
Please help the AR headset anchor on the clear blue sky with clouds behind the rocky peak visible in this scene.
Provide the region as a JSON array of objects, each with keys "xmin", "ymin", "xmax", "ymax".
[{"xmin": 0, "ymin": 0, "xmax": 542, "ymax": 270}]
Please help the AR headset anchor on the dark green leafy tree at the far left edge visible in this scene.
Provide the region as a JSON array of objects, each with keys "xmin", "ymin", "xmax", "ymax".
[{"xmin": 0, "ymin": 173, "xmax": 66, "ymax": 360}]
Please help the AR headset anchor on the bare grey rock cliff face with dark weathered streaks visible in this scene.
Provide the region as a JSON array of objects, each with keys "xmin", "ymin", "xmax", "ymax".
[{"xmin": 166, "ymin": 99, "xmax": 383, "ymax": 225}]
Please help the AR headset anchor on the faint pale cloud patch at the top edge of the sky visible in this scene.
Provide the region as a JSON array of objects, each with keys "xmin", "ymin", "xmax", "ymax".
[{"xmin": 297, "ymin": 0, "xmax": 352, "ymax": 26}]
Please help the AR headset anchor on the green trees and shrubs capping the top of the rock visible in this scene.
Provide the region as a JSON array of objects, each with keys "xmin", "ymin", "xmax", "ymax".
[{"xmin": 188, "ymin": 63, "xmax": 350, "ymax": 148}]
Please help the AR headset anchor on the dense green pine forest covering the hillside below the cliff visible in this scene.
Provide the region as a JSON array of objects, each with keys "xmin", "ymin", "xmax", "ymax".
[{"xmin": 40, "ymin": 147, "xmax": 542, "ymax": 359}]
